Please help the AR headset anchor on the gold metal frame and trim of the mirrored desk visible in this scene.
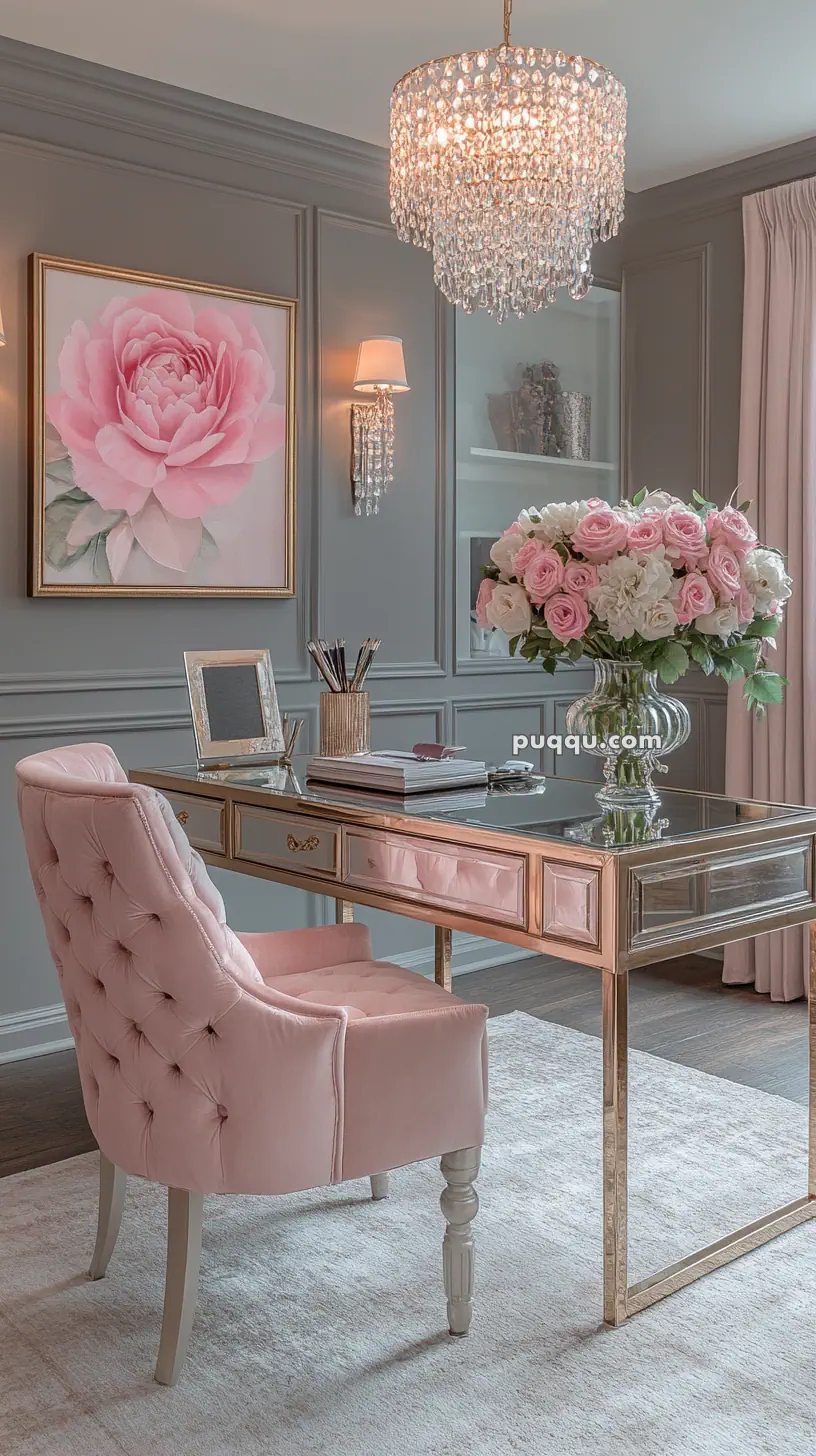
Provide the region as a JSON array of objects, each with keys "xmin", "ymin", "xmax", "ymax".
[{"xmin": 130, "ymin": 769, "xmax": 816, "ymax": 1326}]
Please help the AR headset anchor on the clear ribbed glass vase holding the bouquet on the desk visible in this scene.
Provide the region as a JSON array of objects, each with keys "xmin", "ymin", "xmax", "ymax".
[{"xmin": 567, "ymin": 658, "xmax": 691, "ymax": 807}]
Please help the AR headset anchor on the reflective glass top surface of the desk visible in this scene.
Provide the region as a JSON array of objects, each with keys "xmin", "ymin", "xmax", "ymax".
[{"xmin": 136, "ymin": 757, "xmax": 816, "ymax": 850}]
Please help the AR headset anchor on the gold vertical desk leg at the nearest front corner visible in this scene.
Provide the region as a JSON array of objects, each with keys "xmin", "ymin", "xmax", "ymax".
[{"xmin": 600, "ymin": 971, "xmax": 629, "ymax": 1325}]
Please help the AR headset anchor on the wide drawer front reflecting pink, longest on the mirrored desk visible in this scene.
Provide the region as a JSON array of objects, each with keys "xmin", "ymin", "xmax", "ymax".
[{"xmin": 342, "ymin": 828, "xmax": 527, "ymax": 927}]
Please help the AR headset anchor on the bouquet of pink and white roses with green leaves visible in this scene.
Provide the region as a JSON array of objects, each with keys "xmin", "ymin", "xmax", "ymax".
[{"xmin": 476, "ymin": 491, "xmax": 791, "ymax": 712}]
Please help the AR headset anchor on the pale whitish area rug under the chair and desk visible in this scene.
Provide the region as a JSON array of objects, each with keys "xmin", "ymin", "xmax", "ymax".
[{"xmin": 0, "ymin": 1015, "xmax": 816, "ymax": 1456}]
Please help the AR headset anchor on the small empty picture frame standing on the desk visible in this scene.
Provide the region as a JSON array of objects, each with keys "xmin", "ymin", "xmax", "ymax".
[{"xmin": 184, "ymin": 648, "xmax": 284, "ymax": 769}]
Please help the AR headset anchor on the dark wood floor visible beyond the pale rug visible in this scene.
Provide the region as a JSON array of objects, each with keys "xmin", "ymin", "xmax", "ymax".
[{"xmin": 0, "ymin": 957, "xmax": 807, "ymax": 1176}]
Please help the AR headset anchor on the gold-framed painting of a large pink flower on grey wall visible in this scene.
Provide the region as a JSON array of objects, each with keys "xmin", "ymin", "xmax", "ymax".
[{"xmin": 31, "ymin": 255, "xmax": 296, "ymax": 597}]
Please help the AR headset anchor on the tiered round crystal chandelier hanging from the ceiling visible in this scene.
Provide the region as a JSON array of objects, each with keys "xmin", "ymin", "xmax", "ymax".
[{"xmin": 391, "ymin": 0, "xmax": 627, "ymax": 322}]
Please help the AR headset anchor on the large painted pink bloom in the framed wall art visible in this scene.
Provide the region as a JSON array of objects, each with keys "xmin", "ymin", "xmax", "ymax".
[{"xmin": 47, "ymin": 288, "xmax": 286, "ymax": 569}]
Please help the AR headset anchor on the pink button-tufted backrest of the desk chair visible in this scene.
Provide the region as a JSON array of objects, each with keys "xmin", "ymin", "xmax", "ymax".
[{"xmin": 17, "ymin": 744, "xmax": 347, "ymax": 1192}]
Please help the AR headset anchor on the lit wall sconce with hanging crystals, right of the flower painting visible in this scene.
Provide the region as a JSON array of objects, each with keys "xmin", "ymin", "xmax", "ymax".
[{"xmin": 351, "ymin": 335, "xmax": 411, "ymax": 515}]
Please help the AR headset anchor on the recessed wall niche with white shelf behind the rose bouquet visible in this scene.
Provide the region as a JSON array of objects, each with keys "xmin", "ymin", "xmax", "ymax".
[{"xmin": 455, "ymin": 285, "xmax": 621, "ymax": 668}]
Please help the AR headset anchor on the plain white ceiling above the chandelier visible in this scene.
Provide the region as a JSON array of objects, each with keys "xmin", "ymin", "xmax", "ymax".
[{"xmin": 0, "ymin": 0, "xmax": 816, "ymax": 191}]
